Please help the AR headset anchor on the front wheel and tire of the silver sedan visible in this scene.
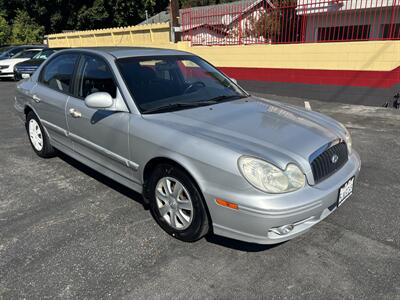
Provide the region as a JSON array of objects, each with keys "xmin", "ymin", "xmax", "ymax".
[{"xmin": 148, "ymin": 164, "xmax": 209, "ymax": 242}]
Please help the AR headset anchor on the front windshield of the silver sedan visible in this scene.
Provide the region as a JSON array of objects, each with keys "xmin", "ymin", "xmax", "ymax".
[{"xmin": 117, "ymin": 55, "xmax": 247, "ymax": 113}]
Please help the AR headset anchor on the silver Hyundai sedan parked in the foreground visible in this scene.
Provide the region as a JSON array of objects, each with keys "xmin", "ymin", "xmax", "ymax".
[{"xmin": 15, "ymin": 48, "xmax": 361, "ymax": 244}]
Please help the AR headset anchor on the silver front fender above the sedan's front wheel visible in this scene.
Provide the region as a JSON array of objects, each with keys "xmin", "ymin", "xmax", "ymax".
[{"xmin": 130, "ymin": 115, "xmax": 251, "ymax": 192}]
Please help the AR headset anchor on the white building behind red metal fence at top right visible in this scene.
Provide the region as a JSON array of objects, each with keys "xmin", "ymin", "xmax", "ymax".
[{"xmin": 296, "ymin": 0, "xmax": 400, "ymax": 42}]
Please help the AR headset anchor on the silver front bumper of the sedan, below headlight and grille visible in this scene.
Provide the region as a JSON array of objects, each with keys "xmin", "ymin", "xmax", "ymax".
[{"xmin": 205, "ymin": 151, "xmax": 361, "ymax": 244}]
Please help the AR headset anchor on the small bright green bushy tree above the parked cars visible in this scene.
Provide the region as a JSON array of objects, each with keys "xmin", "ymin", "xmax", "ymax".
[{"xmin": 11, "ymin": 10, "xmax": 44, "ymax": 44}]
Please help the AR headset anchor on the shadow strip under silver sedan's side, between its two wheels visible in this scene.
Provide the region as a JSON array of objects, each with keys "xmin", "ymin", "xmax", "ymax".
[{"xmin": 57, "ymin": 151, "xmax": 148, "ymax": 210}]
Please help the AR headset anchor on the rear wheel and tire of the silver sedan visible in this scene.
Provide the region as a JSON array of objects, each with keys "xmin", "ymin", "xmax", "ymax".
[{"xmin": 26, "ymin": 111, "xmax": 56, "ymax": 158}]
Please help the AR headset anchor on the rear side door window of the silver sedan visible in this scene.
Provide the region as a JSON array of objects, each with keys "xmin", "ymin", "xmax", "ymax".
[{"xmin": 41, "ymin": 54, "xmax": 78, "ymax": 93}]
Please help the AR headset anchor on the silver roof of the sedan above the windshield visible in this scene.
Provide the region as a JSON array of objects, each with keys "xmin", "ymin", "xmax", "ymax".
[{"xmin": 60, "ymin": 47, "xmax": 193, "ymax": 59}]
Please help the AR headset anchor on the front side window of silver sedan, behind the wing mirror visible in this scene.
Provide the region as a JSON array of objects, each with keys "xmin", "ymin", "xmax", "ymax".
[{"xmin": 78, "ymin": 55, "xmax": 117, "ymax": 98}]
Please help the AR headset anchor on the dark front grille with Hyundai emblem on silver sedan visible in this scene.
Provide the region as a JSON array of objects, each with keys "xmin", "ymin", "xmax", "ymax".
[{"xmin": 311, "ymin": 142, "xmax": 348, "ymax": 184}]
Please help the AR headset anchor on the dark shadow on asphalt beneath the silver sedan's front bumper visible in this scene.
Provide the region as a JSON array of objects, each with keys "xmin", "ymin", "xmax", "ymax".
[{"xmin": 206, "ymin": 234, "xmax": 285, "ymax": 252}]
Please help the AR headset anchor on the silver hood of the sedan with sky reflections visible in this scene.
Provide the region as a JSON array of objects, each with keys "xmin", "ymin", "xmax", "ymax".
[{"xmin": 144, "ymin": 97, "xmax": 345, "ymax": 175}]
